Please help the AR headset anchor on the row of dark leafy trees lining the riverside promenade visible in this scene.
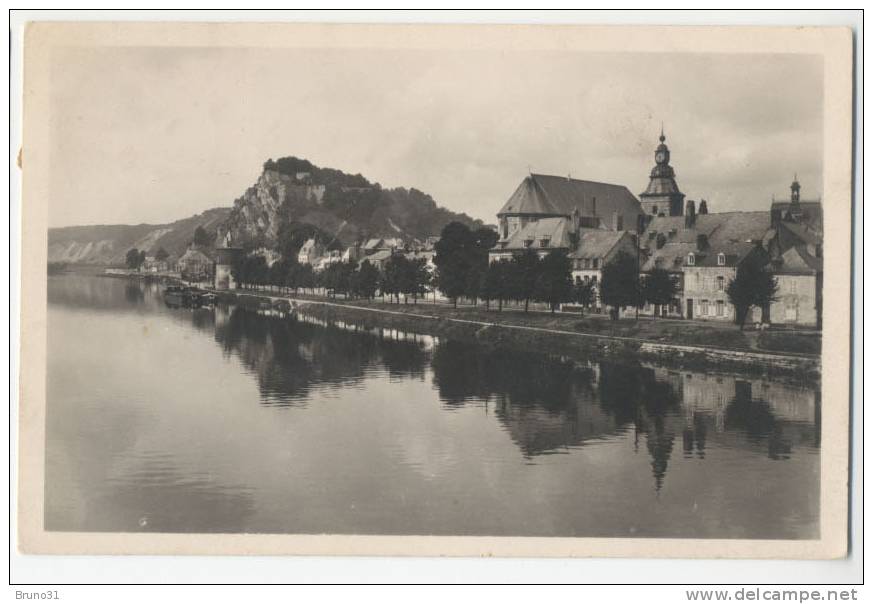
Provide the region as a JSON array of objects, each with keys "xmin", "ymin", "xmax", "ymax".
[{"xmin": 227, "ymin": 222, "xmax": 778, "ymax": 329}]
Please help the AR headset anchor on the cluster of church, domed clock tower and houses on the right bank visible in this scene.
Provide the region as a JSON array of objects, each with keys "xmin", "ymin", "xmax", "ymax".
[{"xmin": 491, "ymin": 132, "xmax": 823, "ymax": 326}]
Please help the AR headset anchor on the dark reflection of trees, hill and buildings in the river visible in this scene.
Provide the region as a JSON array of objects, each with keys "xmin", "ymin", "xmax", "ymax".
[{"xmin": 191, "ymin": 306, "xmax": 821, "ymax": 490}]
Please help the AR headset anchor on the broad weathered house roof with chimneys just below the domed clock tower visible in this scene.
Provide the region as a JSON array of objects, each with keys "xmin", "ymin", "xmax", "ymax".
[{"xmin": 641, "ymin": 212, "xmax": 774, "ymax": 271}]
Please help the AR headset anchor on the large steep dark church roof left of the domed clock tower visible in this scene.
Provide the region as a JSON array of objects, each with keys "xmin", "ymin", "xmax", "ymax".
[{"xmin": 497, "ymin": 174, "xmax": 643, "ymax": 229}]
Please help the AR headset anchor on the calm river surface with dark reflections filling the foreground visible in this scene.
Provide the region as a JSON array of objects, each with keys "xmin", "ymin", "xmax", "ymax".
[{"xmin": 45, "ymin": 275, "xmax": 821, "ymax": 539}]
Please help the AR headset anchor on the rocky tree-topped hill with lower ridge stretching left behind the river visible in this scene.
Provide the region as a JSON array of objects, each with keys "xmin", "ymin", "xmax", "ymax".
[{"xmin": 48, "ymin": 157, "xmax": 483, "ymax": 264}]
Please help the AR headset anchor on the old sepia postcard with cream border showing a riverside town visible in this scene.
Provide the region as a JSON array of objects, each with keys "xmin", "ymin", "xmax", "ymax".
[{"xmin": 17, "ymin": 22, "xmax": 853, "ymax": 558}]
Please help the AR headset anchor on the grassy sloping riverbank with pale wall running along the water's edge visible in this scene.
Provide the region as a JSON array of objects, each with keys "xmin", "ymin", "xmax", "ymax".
[{"xmin": 209, "ymin": 291, "xmax": 821, "ymax": 381}]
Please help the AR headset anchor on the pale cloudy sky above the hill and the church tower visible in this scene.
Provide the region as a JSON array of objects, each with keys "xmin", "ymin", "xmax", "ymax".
[{"xmin": 49, "ymin": 47, "xmax": 824, "ymax": 227}]
